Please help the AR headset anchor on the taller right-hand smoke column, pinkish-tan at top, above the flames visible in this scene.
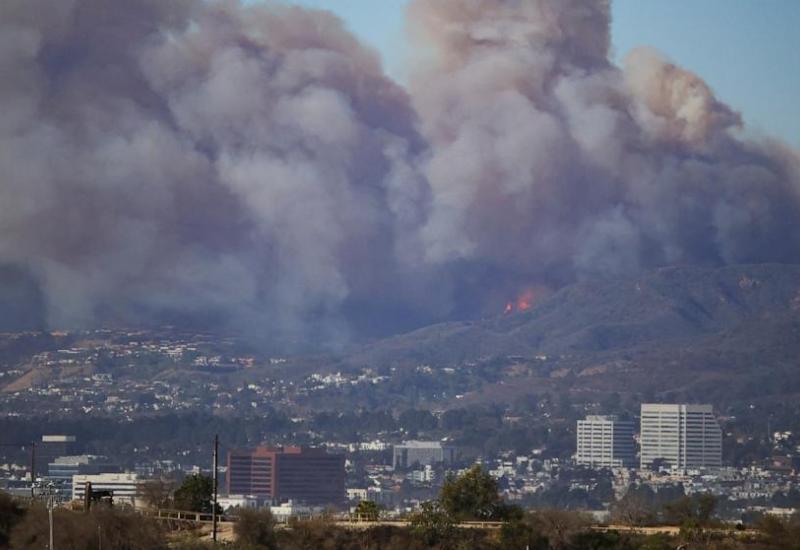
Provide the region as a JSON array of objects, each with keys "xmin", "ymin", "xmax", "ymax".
[{"xmin": 411, "ymin": 0, "xmax": 800, "ymax": 283}]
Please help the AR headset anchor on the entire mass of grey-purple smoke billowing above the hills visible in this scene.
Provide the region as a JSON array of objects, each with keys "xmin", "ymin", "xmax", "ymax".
[{"xmin": 0, "ymin": 0, "xmax": 800, "ymax": 342}]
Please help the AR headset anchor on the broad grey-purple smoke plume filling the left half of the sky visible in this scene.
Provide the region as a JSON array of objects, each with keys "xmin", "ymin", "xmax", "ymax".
[{"xmin": 0, "ymin": 0, "xmax": 435, "ymax": 339}]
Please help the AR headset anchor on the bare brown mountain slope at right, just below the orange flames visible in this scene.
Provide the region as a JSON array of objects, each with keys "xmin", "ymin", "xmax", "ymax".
[{"xmin": 348, "ymin": 264, "xmax": 800, "ymax": 364}]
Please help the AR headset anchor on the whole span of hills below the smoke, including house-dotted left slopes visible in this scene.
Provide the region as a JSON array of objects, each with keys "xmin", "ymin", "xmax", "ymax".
[{"xmin": 0, "ymin": 264, "xmax": 800, "ymax": 414}]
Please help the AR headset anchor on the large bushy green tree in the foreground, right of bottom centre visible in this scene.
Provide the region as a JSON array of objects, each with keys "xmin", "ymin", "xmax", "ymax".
[{"xmin": 439, "ymin": 464, "xmax": 516, "ymax": 521}]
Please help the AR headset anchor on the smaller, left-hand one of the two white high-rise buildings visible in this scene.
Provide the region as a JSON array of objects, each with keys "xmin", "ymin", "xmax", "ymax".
[{"xmin": 575, "ymin": 415, "xmax": 636, "ymax": 468}]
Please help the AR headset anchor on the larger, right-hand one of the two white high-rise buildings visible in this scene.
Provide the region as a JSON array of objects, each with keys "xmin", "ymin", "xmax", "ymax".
[{"xmin": 639, "ymin": 403, "xmax": 722, "ymax": 470}]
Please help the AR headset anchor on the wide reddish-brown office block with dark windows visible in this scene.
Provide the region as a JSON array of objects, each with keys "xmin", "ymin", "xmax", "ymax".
[{"xmin": 227, "ymin": 447, "xmax": 345, "ymax": 505}]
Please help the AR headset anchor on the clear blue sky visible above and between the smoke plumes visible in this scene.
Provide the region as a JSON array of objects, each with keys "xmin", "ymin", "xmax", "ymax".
[{"xmin": 291, "ymin": 0, "xmax": 800, "ymax": 148}]
